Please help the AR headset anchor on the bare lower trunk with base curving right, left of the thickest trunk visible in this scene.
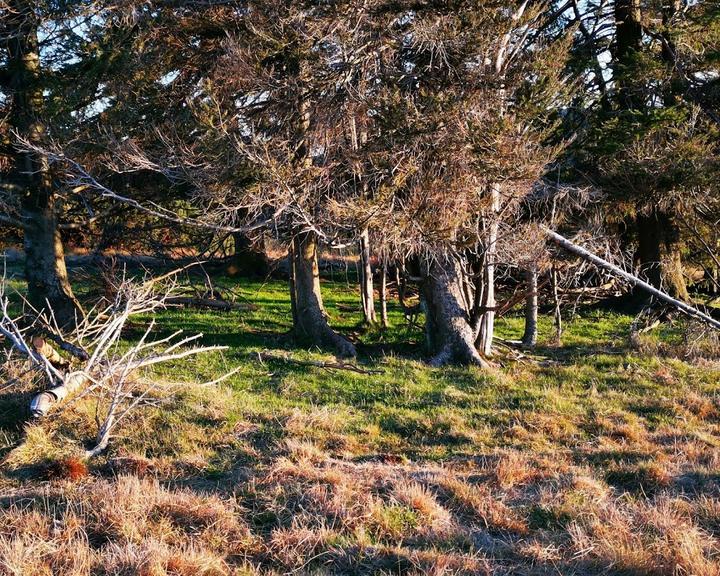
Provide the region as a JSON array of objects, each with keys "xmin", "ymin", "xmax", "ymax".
[{"xmin": 290, "ymin": 232, "xmax": 356, "ymax": 357}]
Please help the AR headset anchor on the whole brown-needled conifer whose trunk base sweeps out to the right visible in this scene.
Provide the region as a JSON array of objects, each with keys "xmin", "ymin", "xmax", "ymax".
[{"xmin": 200, "ymin": 1, "xmax": 402, "ymax": 356}]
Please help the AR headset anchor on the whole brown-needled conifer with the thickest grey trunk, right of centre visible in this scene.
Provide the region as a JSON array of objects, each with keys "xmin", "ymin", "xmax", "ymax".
[{"xmin": 358, "ymin": 2, "xmax": 568, "ymax": 365}]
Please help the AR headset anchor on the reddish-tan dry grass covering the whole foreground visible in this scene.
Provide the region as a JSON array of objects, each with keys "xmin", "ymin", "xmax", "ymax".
[{"xmin": 0, "ymin": 372, "xmax": 720, "ymax": 576}]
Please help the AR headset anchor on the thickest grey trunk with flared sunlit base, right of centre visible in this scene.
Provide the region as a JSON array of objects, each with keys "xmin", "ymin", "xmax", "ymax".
[{"xmin": 423, "ymin": 255, "xmax": 487, "ymax": 366}]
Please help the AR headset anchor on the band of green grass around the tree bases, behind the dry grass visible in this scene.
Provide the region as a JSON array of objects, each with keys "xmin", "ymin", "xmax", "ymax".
[{"xmin": 2, "ymin": 266, "xmax": 718, "ymax": 468}]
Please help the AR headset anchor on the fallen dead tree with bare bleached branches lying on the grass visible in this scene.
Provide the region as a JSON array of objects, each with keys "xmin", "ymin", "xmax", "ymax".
[{"xmin": 0, "ymin": 266, "xmax": 232, "ymax": 457}]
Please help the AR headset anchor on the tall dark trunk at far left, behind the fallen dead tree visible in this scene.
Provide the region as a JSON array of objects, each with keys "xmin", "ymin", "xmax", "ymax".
[{"xmin": 6, "ymin": 0, "xmax": 83, "ymax": 328}]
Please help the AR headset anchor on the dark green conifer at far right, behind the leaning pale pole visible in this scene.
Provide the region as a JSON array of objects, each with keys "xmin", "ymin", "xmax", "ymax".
[{"xmin": 582, "ymin": 0, "xmax": 718, "ymax": 300}]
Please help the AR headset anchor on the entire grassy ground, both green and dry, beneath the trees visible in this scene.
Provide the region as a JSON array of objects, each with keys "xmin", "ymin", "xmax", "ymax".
[{"xmin": 0, "ymin": 264, "xmax": 720, "ymax": 576}]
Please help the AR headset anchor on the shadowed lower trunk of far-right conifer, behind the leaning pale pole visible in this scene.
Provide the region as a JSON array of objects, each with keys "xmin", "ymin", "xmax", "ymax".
[{"xmin": 636, "ymin": 209, "xmax": 690, "ymax": 301}]
